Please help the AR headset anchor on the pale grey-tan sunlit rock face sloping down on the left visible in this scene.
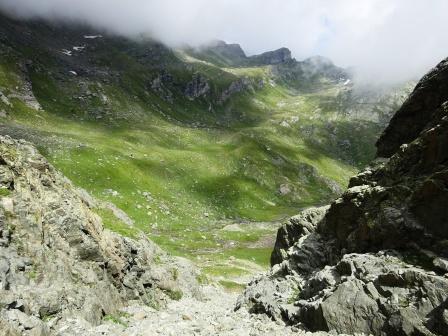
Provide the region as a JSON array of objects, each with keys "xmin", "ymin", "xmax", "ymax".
[{"xmin": 0, "ymin": 137, "xmax": 200, "ymax": 335}]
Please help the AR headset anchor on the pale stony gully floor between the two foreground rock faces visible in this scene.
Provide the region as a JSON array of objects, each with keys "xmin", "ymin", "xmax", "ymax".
[{"xmin": 60, "ymin": 286, "xmax": 327, "ymax": 336}]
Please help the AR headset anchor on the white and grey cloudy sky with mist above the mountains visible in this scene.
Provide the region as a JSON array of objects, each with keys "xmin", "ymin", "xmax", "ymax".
[{"xmin": 0, "ymin": 0, "xmax": 448, "ymax": 81}]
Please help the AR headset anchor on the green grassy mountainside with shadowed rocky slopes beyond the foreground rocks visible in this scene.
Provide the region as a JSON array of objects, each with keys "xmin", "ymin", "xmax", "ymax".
[{"xmin": 0, "ymin": 16, "xmax": 407, "ymax": 288}]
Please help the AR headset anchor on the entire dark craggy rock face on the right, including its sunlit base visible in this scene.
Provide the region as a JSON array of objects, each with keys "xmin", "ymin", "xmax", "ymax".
[{"xmin": 237, "ymin": 60, "xmax": 448, "ymax": 335}]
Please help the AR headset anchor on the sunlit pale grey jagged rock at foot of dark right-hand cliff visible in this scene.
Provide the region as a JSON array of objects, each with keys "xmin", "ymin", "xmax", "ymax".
[{"xmin": 242, "ymin": 251, "xmax": 448, "ymax": 335}]
